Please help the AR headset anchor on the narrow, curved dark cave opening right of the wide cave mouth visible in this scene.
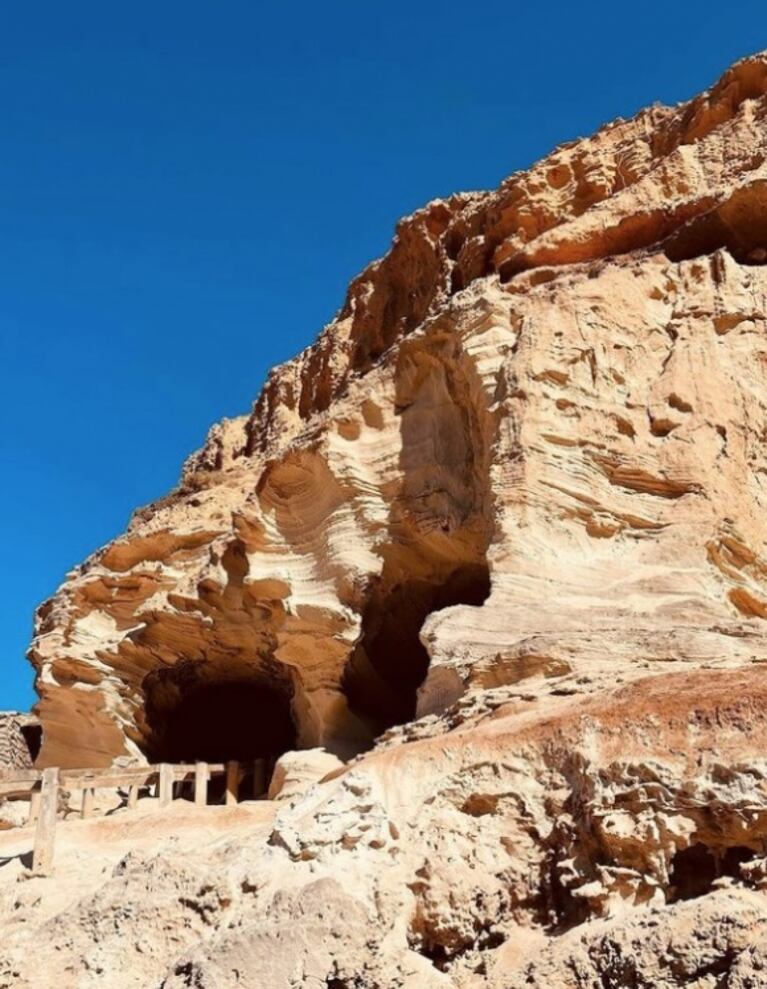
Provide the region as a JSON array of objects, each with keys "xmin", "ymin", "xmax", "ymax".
[{"xmin": 344, "ymin": 563, "xmax": 490, "ymax": 735}]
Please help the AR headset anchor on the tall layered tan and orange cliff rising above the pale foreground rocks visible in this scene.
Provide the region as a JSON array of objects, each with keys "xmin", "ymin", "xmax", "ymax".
[{"xmin": 31, "ymin": 57, "xmax": 767, "ymax": 765}]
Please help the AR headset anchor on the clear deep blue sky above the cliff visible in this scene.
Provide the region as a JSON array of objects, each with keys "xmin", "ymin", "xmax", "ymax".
[{"xmin": 0, "ymin": 0, "xmax": 767, "ymax": 708}]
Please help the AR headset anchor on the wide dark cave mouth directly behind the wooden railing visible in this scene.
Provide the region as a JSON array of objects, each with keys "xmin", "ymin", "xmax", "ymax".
[{"xmin": 145, "ymin": 664, "xmax": 298, "ymax": 763}]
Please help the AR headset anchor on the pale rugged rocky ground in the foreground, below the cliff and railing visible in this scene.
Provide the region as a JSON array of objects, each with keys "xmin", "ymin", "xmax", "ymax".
[{"xmin": 0, "ymin": 667, "xmax": 767, "ymax": 989}]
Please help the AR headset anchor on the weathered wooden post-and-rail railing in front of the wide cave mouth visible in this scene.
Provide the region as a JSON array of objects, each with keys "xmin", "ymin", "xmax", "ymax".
[{"xmin": 0, "ymin": 759, "xmax": 271, "ymax": 876}]
